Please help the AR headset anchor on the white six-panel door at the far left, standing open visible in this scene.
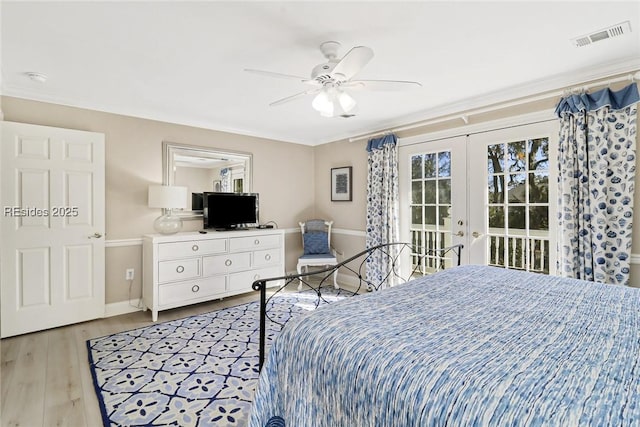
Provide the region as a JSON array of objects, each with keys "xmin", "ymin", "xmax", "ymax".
[{"xmin": 0, "ymin": 122, "xmax": 105, "ymax": 338}]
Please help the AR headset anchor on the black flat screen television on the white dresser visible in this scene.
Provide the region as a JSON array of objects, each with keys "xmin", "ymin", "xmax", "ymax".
[{"xmin": 203, "ymin": 192, "xmax": 259, "ymax": 230}]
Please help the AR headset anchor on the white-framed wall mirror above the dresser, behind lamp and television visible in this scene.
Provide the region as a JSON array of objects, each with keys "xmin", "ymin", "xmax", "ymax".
[{"xmin": 162, "ymin": 141, "xmax": 252, "ymax": 219}]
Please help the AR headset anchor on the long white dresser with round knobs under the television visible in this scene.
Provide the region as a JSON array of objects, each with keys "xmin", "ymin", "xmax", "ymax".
[{"xmin": 142, "ymin": 229, "xmax": 285, "ymax": 322}]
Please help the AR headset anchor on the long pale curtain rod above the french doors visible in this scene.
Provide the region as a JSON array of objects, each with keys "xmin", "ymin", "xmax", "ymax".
[{"xmin": 349, "ymin": 71, "xmax": 640, "ymax": 142}]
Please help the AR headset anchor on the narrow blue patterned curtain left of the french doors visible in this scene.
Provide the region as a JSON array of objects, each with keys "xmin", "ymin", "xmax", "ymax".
[{"xmin": 366, "ymin": 135, "xmax": 400, "ymax": 287}]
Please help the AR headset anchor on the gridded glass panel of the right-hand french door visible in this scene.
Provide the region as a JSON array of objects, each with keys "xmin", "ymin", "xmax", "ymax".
[{"xmin": 487, "ymin": 138, "xmax": 549, "ymax": 273}]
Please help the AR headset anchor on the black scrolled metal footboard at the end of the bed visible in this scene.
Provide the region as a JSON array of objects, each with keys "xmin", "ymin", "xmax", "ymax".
[{"xmin": 252, "ymin": 242, "xmax": 464, "ymax": 370}]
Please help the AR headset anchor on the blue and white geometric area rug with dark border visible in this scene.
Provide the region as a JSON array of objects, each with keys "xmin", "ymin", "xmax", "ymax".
[{"xmin": 87, "ymin": 290, "xmax": 346, "ymax": 427}]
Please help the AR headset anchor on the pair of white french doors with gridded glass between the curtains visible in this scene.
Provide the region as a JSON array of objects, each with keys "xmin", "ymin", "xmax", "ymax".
[{"xmin": 399, "ymin": 121, "xmax": 558, "ymax": 274}]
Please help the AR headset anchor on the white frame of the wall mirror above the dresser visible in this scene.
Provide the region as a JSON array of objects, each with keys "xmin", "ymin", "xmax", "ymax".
[{"xmin": 162, "ymin": 141, "xmax": 253, "ymax": 219}]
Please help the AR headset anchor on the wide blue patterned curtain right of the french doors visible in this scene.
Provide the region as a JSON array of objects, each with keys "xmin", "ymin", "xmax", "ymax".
[{"xmin": 556, "ymin": 84, "xmax": 639, "ymax": 284}]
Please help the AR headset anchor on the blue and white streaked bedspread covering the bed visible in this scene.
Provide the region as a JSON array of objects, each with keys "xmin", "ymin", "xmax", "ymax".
[{"xmin": 250, "ymin": 266, "xmax": 640, "ymax": 427}]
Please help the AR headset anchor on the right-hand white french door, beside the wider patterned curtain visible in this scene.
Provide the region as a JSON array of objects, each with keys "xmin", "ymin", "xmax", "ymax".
[{"xmin": 469, "ymin": 120, "xmax": 558, "ymax": 274}]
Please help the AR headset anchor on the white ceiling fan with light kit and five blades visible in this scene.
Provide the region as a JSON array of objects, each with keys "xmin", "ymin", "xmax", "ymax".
[{"xmin": 245, "ymin": 41, "xmax": 422, "ymax": 117}]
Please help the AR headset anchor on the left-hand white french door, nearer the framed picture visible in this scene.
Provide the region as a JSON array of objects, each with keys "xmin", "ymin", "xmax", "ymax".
[{"xmin": 398, "ymin": 136, "xmax": 468, "ymax": 277}]
